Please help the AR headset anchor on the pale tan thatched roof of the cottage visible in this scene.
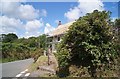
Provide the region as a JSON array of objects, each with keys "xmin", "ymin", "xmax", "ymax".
[{"xmin": 49, "ymin": 21, "xmax": 74, "ymax": 36}]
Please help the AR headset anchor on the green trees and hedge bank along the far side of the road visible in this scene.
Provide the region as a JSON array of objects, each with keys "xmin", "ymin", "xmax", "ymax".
[{"xmin": 0, "ymin": 33, "xmax": 46, "ymax": 62}]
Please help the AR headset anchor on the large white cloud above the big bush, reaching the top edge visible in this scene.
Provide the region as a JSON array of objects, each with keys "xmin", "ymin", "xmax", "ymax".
[{"xmin": 64, "ymin": 0, "xmax": 104, "ymax": 21}]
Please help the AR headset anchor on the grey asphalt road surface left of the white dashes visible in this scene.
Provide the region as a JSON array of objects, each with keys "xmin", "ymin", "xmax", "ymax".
[{"xmin": 0, "ymin": 58, "xmax": 34, "ymax": 77}]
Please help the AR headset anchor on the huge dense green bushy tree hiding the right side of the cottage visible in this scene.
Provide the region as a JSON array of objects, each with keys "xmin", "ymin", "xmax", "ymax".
[{"xmin": 58, "ymin": 10, "xmax": 116, "ymax": 76}]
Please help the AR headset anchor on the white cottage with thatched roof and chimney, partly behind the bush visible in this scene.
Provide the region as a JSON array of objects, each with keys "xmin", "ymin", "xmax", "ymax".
[{"xmin": 47, "ymin": 21, "xmax": 74, "ymax": 52}]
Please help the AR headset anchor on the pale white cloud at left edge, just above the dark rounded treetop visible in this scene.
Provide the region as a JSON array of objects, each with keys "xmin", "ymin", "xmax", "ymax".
[{"xmin": 0, "ymin": 16, "xmax": 23, "ymax": 34}]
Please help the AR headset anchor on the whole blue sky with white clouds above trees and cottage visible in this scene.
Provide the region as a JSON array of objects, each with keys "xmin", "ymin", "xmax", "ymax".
[{"xmin": 0, "ymin": 0, "xmax": 118, "ymax": 38}]
